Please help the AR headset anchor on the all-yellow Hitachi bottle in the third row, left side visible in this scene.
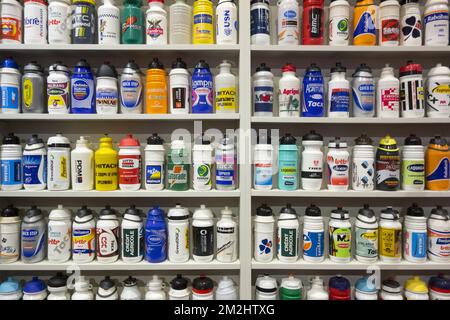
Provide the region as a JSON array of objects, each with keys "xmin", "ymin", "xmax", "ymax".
[{"xmin": 95, "ymin": 135, "xmax": 119, "ymax": 191}]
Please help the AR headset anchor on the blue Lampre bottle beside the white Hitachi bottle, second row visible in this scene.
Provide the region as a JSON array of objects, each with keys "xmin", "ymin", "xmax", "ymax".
[{"xmin": 192, "ymin": 60, "xmax": 214, "ymax": 113}]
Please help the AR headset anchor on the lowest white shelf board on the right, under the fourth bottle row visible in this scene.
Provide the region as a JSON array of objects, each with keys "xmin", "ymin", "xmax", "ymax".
[{"xmin": 252, "ymin": 259, "xmax": 450, "ymax": 270}]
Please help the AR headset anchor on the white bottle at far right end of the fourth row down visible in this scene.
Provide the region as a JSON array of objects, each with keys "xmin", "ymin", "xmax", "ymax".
[{"xmin": 427, "ymin": 206, "xmax": 450, "ymax": 262}]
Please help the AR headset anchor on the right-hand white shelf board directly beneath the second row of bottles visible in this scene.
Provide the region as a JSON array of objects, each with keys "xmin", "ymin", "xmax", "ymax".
[{"xmin": 252, "ymin": 117, "xmax": 450, "ymax": 125}]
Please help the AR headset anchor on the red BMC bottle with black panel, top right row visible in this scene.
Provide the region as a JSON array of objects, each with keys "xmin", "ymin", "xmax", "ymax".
[{"xmin": 302, "ymin": 0, "xmax": 324, "ymax": 45}]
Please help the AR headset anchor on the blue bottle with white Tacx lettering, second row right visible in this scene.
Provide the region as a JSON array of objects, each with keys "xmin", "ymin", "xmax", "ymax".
[{"xmin": 302, "ymin": 63, "xmax": 325, "ymax": 117}]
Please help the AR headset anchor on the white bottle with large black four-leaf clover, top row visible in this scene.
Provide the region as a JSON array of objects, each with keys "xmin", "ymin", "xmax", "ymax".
[{"xmin": 400, "ymin": 1, "xmax": 423, "ymax": 46}]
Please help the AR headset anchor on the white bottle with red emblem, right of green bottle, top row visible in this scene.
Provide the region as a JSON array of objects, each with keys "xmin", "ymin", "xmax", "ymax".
[{"xmin": 145, "ymin": 0, "xmax": 168, "ymax": 45}]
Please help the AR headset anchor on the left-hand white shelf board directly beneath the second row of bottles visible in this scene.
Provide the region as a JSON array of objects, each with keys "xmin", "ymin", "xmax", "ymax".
[{"xmin": 0, "ymin": 113, "xmax": 239, "ymax": 121}]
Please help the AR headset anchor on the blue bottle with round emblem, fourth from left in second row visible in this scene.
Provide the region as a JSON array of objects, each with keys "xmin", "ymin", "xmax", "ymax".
[{"xmin": 70, "ymin": 59, "xmax": 95, "ymax": 113}]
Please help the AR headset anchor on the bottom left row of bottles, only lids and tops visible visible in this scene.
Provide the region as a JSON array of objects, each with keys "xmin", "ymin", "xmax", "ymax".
[{"xmin": 0, "ymin": 273, "xmax": 238, "ymax": 300}]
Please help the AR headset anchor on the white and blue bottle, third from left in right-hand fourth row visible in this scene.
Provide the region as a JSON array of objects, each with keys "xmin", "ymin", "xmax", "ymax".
[{"xmin": 303, "ymin": 204, "xmax": 325, "ymax": 262}]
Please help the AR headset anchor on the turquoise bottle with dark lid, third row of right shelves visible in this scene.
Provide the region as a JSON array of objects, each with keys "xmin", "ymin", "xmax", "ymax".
[{"xmin": 278, "ymin": 133, "xmax": 298, "ymax": 190}]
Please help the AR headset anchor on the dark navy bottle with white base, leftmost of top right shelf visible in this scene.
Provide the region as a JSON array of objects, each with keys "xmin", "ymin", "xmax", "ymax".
[{"xmin": 250, "ymin": 0, "xmax": 270, "ymax": 46}]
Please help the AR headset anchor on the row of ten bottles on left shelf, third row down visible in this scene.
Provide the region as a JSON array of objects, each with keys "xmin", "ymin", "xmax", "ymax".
[{"xmin": 0, "ymin": 133, "xmax": 237, "ymax": 191}]
